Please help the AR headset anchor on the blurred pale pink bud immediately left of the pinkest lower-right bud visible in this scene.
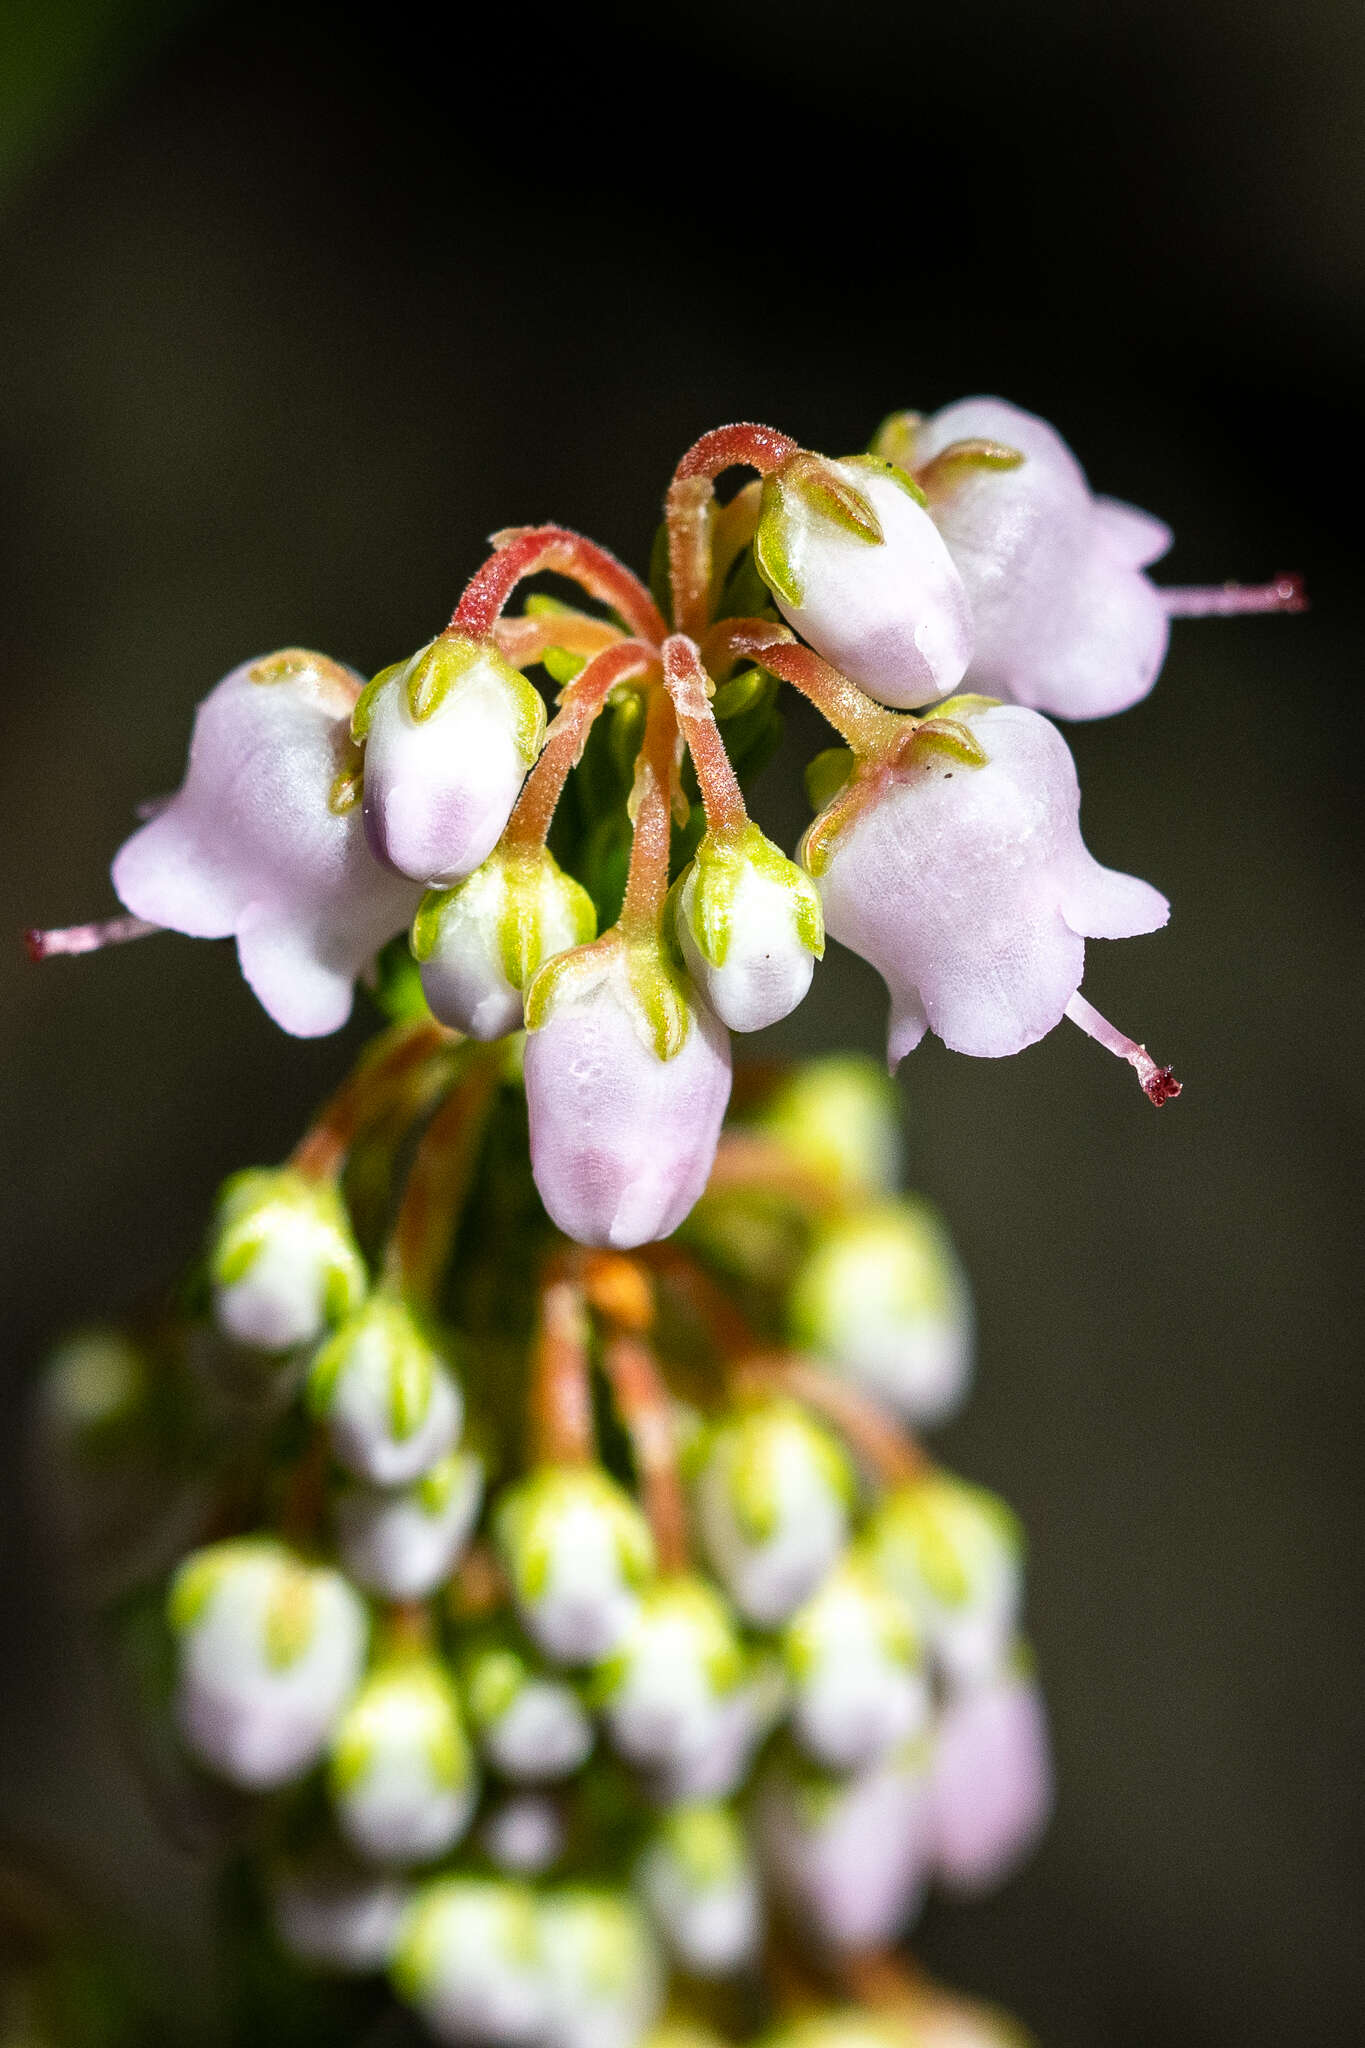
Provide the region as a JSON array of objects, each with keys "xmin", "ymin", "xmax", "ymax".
[{"xmin": 755, "ymin": 1749, "xmax": 931, "ymax": 1948}]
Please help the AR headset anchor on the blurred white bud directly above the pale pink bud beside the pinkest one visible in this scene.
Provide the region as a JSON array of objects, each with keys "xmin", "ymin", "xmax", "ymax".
[{"xmin": 782, "ymin": 1556, "xmax": 929, "ymax": 1772}]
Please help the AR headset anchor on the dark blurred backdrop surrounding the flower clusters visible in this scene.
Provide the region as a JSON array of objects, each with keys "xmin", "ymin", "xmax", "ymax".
[{"xmin": 0, "ymin": 0, "xmax": 1365, "ymax": 2048}]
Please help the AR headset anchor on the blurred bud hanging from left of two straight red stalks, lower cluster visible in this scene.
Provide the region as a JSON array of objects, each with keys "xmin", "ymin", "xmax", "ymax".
[{"xmin": 495, "ymin": 1464, "xmax": 655, "ymax": 1663}]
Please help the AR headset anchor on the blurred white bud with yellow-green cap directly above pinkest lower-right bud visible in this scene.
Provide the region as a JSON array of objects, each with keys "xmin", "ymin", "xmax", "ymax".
[{"xmin": 866, "ymin": 1470, "xmax": 1023, "ymax": 1686}]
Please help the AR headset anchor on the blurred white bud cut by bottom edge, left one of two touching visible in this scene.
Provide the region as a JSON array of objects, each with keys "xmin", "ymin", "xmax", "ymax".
[{"xmin": 393, "ymin": 1878, "xmax": 546, "ymax": 2048}]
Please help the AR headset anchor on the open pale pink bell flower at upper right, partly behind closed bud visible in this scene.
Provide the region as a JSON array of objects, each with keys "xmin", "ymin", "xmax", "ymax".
[{"xmin": 913, "ymin": 397, "xmax": 1171, "ymax": 719}]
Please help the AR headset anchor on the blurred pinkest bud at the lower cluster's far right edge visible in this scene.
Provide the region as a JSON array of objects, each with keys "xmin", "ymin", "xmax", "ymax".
[{"xmin": 929, "ymin": 1657, "xmax": 1052, "ymax": 1896}]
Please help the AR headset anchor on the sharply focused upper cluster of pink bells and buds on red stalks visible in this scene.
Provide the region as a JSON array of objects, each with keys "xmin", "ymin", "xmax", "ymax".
[{"xmin": 33, "ymin": 399, "xmax": 1300, "ymax": 1249}]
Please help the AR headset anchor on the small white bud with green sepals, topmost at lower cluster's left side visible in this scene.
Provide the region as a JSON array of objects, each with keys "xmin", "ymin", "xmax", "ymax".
[{"xmin": 209, "ymin": 1167, "xmax": 366, "ymax": 1352}]
